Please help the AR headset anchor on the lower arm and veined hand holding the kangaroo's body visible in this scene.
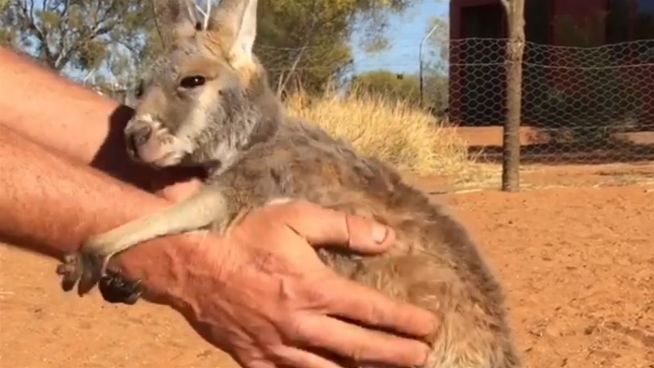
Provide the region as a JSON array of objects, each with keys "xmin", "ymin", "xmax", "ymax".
[{"xmin": 0, "ymin": 122, "xmax": 435, "ymax": 368}]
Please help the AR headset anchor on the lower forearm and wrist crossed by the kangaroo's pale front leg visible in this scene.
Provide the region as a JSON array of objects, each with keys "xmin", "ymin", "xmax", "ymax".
[{"xmin": 0, "ymin": 126, "xmax": 191, "ymax": 304}]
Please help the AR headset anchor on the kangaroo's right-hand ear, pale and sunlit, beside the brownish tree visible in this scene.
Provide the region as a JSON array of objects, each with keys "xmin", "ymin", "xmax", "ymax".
[{"xmin": 207, "ymin": 0, "xmax": 257, "ymax": 68}]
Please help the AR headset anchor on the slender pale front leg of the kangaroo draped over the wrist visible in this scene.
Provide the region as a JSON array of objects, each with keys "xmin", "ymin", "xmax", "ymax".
[{"xmin": 58, "ymin": 187, "xmax": 232, "ymax": 295}]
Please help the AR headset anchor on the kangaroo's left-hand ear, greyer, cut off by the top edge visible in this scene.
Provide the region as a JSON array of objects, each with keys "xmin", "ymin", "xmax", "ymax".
[{"xmin": 152, "ymin": 0, "xmax": 198, "ymax": 47}]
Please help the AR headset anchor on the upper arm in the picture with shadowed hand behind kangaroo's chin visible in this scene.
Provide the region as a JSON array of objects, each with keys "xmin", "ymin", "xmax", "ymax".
[{"xmin": 0, "ymin": 47, "xmax": 200, "ymax": 189}]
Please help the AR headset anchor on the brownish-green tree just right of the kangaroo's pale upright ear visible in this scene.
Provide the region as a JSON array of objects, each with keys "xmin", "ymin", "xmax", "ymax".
[{"xmin": 255, "ymin": 0, "xmax": 409, "ymax": 92}]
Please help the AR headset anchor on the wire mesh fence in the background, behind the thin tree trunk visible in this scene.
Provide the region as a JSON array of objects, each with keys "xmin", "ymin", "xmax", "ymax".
[{"xmin": 97, "ymin": 38, "xmax": 654, "ymax": 191}]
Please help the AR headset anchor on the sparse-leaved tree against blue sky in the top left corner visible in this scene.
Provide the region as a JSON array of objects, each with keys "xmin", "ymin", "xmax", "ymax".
[{"xmin": 0, "ymin": 0, "xmax": 161, "ymax": 86}]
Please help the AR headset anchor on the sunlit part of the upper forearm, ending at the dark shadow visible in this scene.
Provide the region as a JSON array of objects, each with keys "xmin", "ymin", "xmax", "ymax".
[{"xmin": 0, "ymin": 48, "xmax": 131, "ymax": 163}]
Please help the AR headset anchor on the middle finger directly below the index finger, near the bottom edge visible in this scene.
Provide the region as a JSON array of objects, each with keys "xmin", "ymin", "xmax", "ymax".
[{"xmin": 297, "ymin": 316, "xmax": 429, "ymax": 366}]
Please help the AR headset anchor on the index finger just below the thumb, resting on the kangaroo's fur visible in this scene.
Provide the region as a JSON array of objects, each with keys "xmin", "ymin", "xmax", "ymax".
[{"xmin": 317, "ymin": 277, "xmax": 439, "ymax": 337}]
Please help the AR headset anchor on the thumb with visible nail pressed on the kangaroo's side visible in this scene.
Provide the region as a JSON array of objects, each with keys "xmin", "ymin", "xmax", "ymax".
[{"xmin": 271, "ymin": 201, "xmax": 395, "ymax": 254}]
